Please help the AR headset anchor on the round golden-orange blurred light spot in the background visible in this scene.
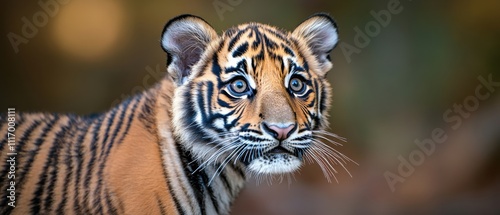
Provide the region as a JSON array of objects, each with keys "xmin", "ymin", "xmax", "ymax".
[{"xmin": 54, "ymin": 0, "xmax": 125, "ymax": 60}]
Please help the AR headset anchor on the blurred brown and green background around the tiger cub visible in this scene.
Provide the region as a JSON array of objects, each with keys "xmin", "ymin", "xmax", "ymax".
[{"xmin": 0, "ymin": 0, "xmax": 500, "ymax": 215}]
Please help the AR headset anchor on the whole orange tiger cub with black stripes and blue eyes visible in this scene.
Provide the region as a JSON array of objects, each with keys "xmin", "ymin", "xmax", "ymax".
[{"xmin": 0, "ymin": 14, "xmax": 349, "ymax": 214}]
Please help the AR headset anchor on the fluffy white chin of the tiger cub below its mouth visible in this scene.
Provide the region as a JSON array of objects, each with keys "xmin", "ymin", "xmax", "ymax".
[{"xmin": 248, "ymin": 153, "xmax": 302, "ymax": 174}]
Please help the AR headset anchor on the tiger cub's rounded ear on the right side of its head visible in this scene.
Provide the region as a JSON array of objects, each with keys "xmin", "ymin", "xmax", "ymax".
[{"xmin": 292, "ymin": 13, "xmax": 339, "ymax": 75}]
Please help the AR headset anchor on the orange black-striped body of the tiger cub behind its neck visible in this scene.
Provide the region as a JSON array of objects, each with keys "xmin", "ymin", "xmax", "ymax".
[{"xmin": 0, "ymin": 85, "xmax": 182, "ymax": 214}]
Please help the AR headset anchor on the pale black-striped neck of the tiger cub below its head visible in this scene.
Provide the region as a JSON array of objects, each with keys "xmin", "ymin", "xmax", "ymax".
[{"xmin": 156, "ymin": 80, "xmax": 245, "ymax": 214}]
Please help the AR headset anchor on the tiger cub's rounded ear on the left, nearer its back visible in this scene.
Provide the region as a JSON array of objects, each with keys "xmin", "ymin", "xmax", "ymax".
[{"xmin": 161, "ymin": 14, "xmax": 217, "ymax": 85}]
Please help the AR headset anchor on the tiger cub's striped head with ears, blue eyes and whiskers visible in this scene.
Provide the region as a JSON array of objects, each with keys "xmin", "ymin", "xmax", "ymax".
[{"xmin": 161, "ymin": 14, "xmax": 343, "ymax": 179}]
